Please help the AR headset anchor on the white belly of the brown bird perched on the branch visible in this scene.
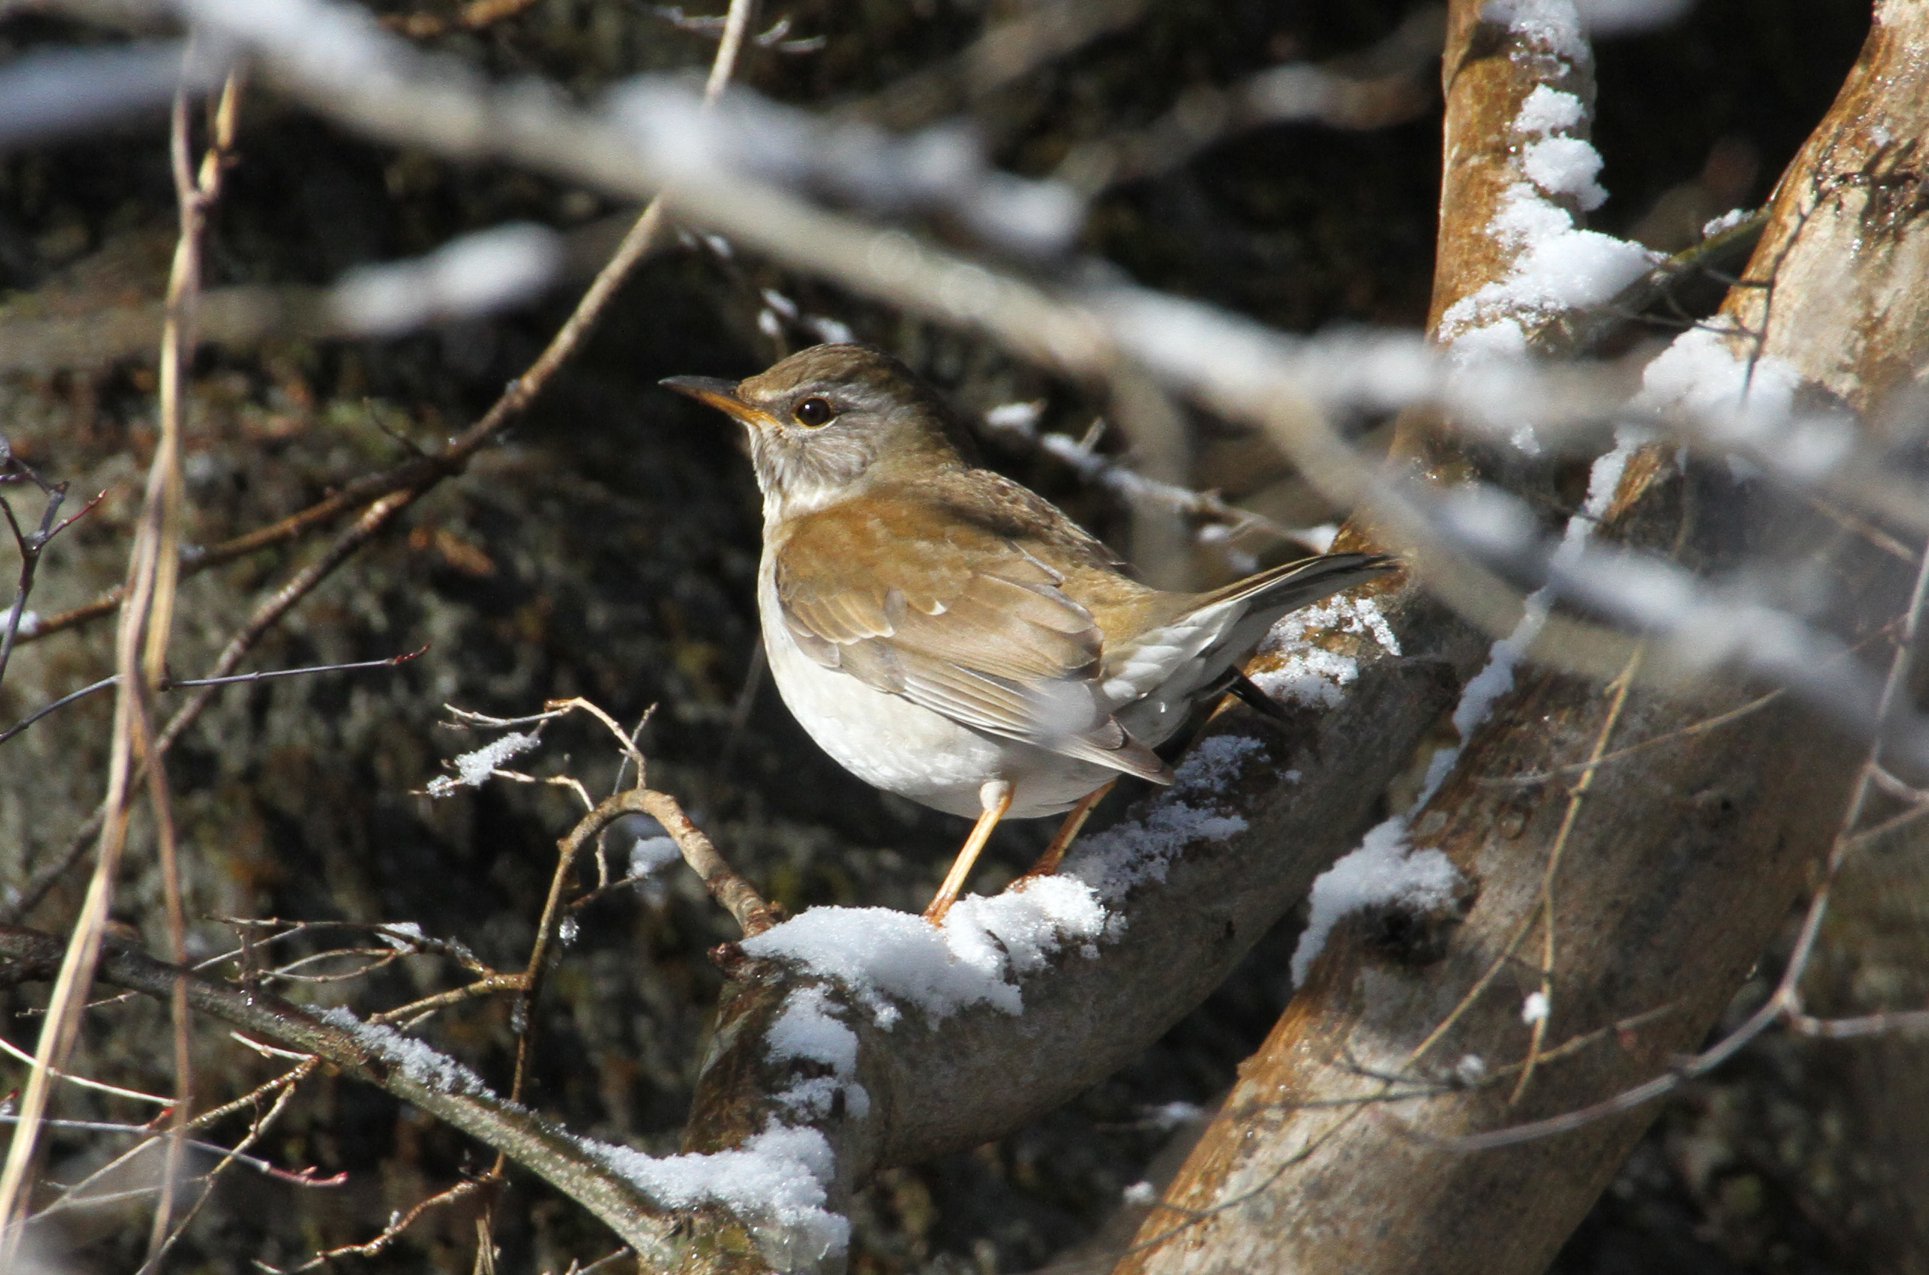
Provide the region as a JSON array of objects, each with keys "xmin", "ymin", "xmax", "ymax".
[{"xmin": 764, "ymin": 590, "xmax": 1115, "ymax": 820}]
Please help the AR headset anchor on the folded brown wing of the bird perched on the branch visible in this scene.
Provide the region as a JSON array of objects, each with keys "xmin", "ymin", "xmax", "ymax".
[{"xmin": 774, "ymin": 496, "xmax": 1171, "ymax": 783}]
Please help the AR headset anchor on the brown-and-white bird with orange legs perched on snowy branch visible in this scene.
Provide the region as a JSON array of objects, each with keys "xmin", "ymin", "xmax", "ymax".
[{"xmin": 660, "ymin": 343, "xmax": 1397, "ymax": 926}]
